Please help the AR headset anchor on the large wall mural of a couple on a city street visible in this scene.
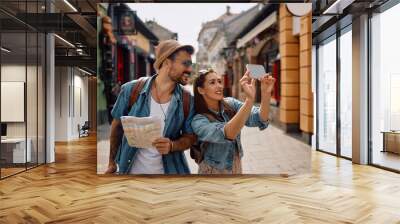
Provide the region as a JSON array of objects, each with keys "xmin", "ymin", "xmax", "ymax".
[{"xmin": 97, "ymin": 3, "xmax": 311, "ymax": 175}]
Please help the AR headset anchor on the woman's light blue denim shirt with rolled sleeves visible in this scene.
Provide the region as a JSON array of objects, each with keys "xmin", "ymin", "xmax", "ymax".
[{"xmin": 192, "ymin": 97, "xmax": 269, "ymax": 170}]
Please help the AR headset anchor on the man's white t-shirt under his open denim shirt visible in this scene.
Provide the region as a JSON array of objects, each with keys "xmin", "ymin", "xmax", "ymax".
[{"xmin": 129, "ymin": 97, "xmax": 171, "ymax": 174}]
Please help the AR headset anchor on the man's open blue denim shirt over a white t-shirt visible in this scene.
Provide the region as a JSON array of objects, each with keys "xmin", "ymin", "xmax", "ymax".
[{"xmin": 111, "ymin": 76, "xmax": 194, "ymax": 174}]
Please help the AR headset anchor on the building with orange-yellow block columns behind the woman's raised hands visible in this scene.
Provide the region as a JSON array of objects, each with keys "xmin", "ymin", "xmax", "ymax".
[{"xmin": 225, "ymin": 4, "xmax": 313, "ymax": 144}]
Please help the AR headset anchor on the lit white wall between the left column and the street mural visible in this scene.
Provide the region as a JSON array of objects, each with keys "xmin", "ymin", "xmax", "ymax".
[{"xmin": 55, "ymin": 67, "xmax": 89, "ymax": 141}]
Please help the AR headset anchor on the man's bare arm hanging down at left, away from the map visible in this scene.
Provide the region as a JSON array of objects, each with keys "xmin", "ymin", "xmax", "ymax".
[{"xmin": 106, "ymin": 119, "xmax": 124, "ymax": 174}]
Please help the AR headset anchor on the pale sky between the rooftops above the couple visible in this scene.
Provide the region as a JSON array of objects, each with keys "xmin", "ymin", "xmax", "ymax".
[{"xmin": 128, "ymin": 3, "xmax": 256, "ymax": 61}]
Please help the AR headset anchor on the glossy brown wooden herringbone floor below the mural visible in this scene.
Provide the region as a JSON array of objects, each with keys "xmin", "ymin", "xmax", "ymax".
[{"xmin": 0, "ymin": 134, "xmax": 400, "ymax": 224}]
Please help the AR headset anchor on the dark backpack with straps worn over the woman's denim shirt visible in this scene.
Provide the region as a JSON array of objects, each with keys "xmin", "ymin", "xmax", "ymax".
[{"xmin": 190, "ymin": 101, "xmax": 236, "ymax": 164}]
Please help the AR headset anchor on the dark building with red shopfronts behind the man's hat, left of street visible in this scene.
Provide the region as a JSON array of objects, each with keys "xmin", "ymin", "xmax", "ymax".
[{"xmin": 98, "ymin": 3, "xmax": 159, "ymax": 124}]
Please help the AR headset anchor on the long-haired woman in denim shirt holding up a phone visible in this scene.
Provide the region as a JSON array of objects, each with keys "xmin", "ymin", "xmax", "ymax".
[{"xmin": 191, "ymin": 69, "xmax": 275, "ymax": 174}]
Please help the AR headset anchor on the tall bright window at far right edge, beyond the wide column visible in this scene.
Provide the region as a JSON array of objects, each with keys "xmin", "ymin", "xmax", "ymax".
[{"xmin": 370, "ymin": 4, "xmax": 400, "ymax": 170}]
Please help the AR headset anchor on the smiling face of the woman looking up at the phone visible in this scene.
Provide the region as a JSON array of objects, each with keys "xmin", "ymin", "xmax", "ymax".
[{"xmin": 198, "ymin": 72, "xmax": 224, "ymax": 102}]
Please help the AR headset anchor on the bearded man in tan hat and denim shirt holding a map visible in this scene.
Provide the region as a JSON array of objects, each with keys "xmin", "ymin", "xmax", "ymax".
[{"xmin": 106, "ymin": 40, "xmax": 196, "ymax": 174}]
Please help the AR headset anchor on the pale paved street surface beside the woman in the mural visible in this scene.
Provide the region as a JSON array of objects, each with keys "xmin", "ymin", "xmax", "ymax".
[{"xmin": 185, "ymin": 125, "xmax": 311, "ymax": 175}]
